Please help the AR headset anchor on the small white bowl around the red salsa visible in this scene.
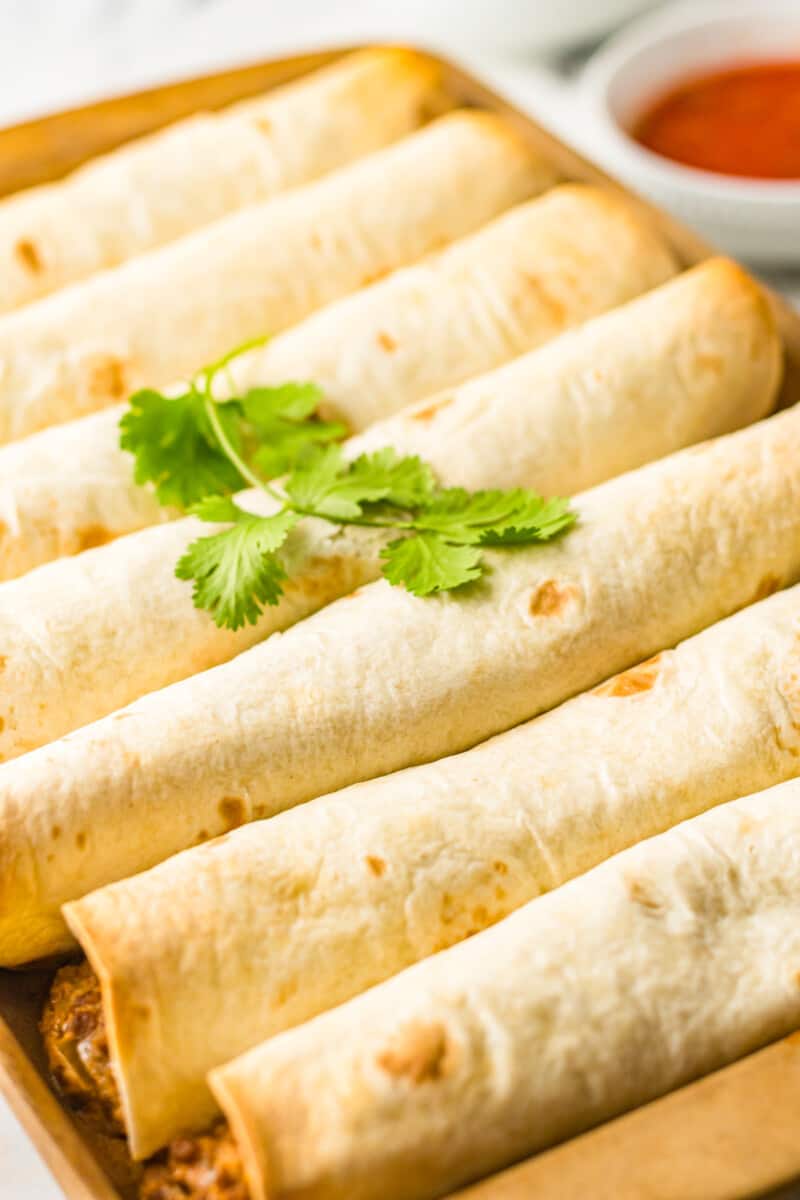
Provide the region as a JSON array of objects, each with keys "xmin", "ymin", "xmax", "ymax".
[{"xmin": 582, "ymin": 0, "xmax": 800, "ymax": 266}]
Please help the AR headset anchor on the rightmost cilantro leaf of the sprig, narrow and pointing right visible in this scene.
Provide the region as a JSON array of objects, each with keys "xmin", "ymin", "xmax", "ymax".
[{"xmin": 414, "ymin": 487, "xmax": 575, "ymax": 546}]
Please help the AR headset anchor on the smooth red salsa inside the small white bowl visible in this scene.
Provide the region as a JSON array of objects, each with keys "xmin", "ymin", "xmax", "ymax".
[{"xmin": 632, "ymin": 60, "xmax": 800, "ymax": 180}]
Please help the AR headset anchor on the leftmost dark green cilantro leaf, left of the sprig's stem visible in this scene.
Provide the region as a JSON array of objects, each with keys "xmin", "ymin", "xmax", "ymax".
[{"xmin": 120, "ymin": 389, "xmax": 243, "ymax": 509}]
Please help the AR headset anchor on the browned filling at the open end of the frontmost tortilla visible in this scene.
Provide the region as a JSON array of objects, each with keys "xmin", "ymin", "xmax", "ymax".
[{"xmin": 139, "ymin": 1121, "xmax": 249, "ymax": 1200}]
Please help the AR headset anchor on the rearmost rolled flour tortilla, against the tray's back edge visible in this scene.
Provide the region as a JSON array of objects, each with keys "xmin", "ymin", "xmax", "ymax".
[{"xmin": 0, "ymin": 49, "xmax": 450, "ymax": 312}]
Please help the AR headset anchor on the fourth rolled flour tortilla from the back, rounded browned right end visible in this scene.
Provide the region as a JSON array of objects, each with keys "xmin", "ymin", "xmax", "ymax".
[{"xmin": 0, "ymin": 260, "xmax": 767, "ymax": 758}]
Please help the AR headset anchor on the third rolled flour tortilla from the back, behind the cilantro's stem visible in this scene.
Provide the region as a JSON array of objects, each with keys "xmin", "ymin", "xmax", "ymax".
[{"xmin": 0, "ymin": 187, "xmax": 675, "ymax": 580}]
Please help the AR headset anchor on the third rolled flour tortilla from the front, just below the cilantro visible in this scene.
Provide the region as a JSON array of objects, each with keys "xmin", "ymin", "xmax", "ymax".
[{"xmin": 0, "ymin": 374, "xmax": 800, "ymax": 965}]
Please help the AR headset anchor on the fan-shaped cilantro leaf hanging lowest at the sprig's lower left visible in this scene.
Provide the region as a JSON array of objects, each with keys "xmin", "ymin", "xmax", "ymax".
[{"xmin": 175, "ymin": 504, "xmax": 300, "ymax": 630}]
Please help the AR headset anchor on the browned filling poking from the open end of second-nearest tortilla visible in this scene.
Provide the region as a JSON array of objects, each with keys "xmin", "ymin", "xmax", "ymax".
[{"xmin": 41, "ymin": 962, "xmax": 125, "ymax": 1136}]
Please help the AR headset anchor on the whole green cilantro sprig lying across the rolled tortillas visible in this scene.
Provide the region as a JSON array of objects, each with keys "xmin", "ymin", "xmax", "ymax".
[{"xmin": 121, "ymin": 343, "xmax": 576, "ymax": 630}]
